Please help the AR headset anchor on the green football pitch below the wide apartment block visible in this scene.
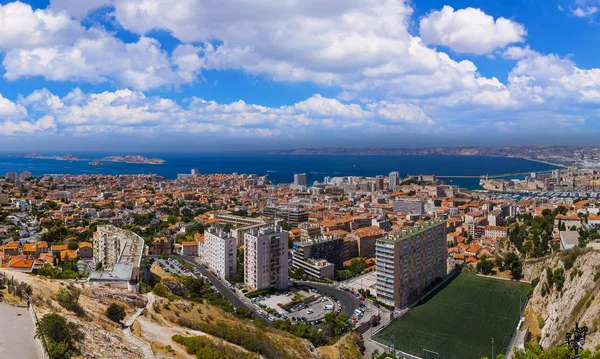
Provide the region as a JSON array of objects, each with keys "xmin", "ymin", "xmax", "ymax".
[{"xmin": 374, "ymin": 274, "xmax": 529, "ymax": 359}]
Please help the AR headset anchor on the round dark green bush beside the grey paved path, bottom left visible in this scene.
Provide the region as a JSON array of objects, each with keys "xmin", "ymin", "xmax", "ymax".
[{"xmin": 35, "ymin": 313, "xmax": 84, "ymax": 359}]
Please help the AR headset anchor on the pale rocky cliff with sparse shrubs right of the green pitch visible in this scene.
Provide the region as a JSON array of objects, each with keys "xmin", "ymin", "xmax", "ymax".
[{"xmin": 524, "ymin": 251, "xmax": 600, "ymax": 348}]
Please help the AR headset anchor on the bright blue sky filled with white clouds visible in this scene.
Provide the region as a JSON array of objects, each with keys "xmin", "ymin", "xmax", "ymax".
[{"xmin": 0, "ymin": 0, "xmax": 600, "ymax": 152}]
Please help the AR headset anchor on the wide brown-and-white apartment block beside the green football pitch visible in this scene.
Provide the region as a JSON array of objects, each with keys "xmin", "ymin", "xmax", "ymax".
[{"xmin": 375, "ymin": 220, "xmax": 447, "ymax": 308}]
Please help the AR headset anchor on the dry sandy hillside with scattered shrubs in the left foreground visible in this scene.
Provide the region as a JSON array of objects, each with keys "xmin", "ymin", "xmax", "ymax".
[{"xmin": 0, "ymin": 270, "xmax": 317, "ymax": 359}]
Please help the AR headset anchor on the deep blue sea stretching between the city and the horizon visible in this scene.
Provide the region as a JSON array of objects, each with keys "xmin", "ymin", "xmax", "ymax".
[{"xmin": 0, "ymin": 152, "xmax": 556, "ymax": 189}]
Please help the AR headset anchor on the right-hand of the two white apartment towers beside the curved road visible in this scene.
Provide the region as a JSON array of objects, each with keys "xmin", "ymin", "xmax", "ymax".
[{"xmin": 244, "ymin": 226, "xmax": 289, "ymax": 290}]
